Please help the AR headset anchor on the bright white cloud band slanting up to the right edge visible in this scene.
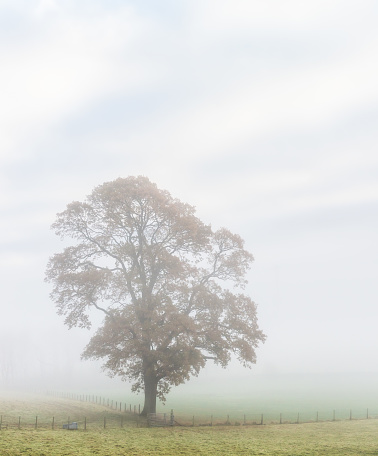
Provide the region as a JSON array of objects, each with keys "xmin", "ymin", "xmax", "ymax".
[{"xmin": 102, "ymin": 40, "xmax": 378, "ymax": 175}]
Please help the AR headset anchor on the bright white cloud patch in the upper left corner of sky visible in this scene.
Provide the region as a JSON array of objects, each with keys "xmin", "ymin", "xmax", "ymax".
[{"xmin": 0, "ymin": 2, "xmax": 159, "ymax": 164}]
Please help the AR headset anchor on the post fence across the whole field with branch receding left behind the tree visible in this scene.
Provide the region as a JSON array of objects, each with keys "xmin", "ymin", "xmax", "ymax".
[{"xmin": 0, "ymin": 391, "xmax": 378, "ymax": 430}]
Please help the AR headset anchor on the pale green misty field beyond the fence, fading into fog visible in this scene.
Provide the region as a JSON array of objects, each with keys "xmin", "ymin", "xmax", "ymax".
[{"xmin": 88, "ymin": 370, "xmax": 378, "ymax": 424}]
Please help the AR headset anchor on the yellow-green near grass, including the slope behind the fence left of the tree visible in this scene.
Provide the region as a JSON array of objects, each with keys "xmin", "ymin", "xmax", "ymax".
[{"xmin": 0, "ymin": 398, "xmax": 378, "ymax": 456}]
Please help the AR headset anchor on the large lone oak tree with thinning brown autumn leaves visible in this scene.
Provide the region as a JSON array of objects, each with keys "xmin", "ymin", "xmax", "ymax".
[{"xmin": 46, "ymin": 176, "xmax": 265, "ymax": 414}]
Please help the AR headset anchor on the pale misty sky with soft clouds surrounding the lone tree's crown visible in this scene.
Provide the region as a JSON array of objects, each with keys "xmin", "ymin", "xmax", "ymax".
[{"xmin": 0, "ymin": 0, "xmax": 378, "ymax": 392}]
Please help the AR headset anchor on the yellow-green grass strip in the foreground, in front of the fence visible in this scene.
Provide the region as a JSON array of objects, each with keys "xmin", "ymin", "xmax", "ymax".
[{"xmin": 0, "ymin": 420, "xmax": 378, "ymax": 456}]
